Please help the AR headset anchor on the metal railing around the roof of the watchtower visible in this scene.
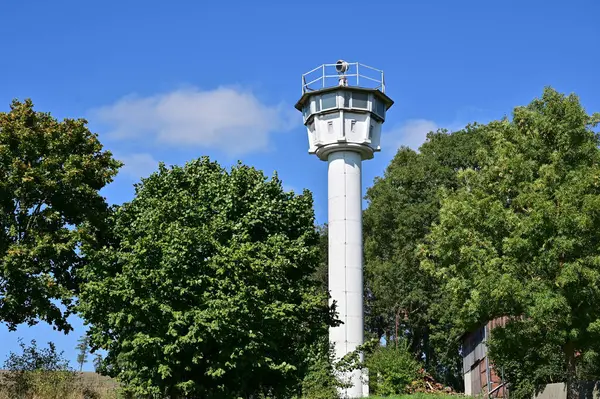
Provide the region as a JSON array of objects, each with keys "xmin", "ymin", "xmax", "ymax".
[{"xmin": 302, "ymin": 62, "xmax": 385, "ymax": 94}]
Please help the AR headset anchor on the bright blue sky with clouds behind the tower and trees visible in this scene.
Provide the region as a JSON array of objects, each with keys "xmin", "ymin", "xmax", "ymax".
[{"xmin": 0, "ymin": 0, "xmax": 600, "ymax": 370}]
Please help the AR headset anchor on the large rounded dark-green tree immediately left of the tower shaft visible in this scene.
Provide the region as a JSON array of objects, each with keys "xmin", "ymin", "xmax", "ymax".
[{"xmin": 79, "ymin": 157, "xmax": 331, "ymax": 398}]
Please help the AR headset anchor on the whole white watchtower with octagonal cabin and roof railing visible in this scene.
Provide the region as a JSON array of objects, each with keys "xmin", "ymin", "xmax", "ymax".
[{"xmin": 296, "ymin": 60, "xmax": 394, "ymax": 399}]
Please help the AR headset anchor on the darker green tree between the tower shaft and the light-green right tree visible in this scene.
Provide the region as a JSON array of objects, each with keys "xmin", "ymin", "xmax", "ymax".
[{"xmin": 364, "ymin": 125, "xmax": 484, "ymax": 388}]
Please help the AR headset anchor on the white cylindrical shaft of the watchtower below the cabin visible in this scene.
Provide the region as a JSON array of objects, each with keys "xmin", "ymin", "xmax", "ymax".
[{"xmin": 328, "ymin": 150, "xmax": 369, "ymax": 399}]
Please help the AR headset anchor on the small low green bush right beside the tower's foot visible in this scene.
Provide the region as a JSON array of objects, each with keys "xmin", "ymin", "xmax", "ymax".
[{"xmin": 366, "ymin": 345, "xmax": 421, "ymax": 396}]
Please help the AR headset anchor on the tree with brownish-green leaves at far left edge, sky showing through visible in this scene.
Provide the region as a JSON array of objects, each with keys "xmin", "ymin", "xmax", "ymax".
[{"xmin": 0, "ymin": 100, "xmax": 120, "ymax": 332}]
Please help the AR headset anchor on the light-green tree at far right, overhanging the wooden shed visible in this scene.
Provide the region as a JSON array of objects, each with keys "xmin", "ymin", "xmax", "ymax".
[{"xmin": 422, "ymin": 88, "xmax": 600, "ymax": 399}]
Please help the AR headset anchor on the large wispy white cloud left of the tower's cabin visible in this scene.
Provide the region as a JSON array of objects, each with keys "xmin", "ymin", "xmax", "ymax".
[{"xmin": 90, "ymin": 87, "xmax": 300, "ymax": 156}]
